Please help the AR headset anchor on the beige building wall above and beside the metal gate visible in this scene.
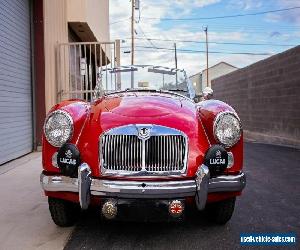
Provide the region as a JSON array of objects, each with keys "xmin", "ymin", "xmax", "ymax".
[{"xmin": 43, "ymin": 0, "xmax": 110, "ymax": 111}]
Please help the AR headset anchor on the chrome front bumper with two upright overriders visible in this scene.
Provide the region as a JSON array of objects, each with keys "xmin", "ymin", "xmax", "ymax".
[{"xmin": 40, "ymin": 163, "xmax": 246, "ymax": 210}]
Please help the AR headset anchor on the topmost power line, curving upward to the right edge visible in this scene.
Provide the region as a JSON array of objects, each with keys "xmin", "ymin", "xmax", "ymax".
[{"xmin": 143, "ymin": 6, "xmax": 300, "ymax": 21}]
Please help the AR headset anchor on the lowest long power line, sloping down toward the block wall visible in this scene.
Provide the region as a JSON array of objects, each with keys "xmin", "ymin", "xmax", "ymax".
[{"xmin": 122, "ymin": 45, "xmax": 273, "ymax": 56}]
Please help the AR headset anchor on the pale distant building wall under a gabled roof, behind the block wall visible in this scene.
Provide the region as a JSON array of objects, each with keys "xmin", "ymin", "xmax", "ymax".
[{"xmin": 202, "ymin": 63, "xmax": 237, "ymax": 88}]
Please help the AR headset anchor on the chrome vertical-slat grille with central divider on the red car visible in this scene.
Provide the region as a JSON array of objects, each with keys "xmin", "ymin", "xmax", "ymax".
[{"xmin": 100, "ymin": 131, "xmax": 187, "ymax": 173}]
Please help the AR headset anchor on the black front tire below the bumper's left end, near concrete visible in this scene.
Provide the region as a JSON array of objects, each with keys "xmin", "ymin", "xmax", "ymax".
[{"xmin": 48, "ymin": 197, "xmax": 80, "ymax": 227}]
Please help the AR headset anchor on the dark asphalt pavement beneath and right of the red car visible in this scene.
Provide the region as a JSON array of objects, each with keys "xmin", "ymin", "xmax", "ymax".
[{"xmin": 65, "ymin": 143, "xmax": 300, "ymax": 249}]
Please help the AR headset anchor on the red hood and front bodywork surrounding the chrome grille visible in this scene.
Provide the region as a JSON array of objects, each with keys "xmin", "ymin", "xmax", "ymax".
[{"xmin": 74, "ymin": 92, "xmax": 209, "ymax": 179}]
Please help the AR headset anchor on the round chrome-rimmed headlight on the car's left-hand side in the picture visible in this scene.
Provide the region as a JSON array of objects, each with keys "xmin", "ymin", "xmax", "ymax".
[{"xmin": 44, "ymin": 110, "xmax": 73, "ymax": 147}]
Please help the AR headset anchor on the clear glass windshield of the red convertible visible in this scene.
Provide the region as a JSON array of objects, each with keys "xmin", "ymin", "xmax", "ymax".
[{"xmin": 95, "ymin": 65, "xmax": 194, "ymax": 98}]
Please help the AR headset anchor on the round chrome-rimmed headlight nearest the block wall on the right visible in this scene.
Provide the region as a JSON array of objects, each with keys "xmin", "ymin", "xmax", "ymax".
[{"xmin": 214, "ymin": 111, "xmax": 242, "ymax": 147}]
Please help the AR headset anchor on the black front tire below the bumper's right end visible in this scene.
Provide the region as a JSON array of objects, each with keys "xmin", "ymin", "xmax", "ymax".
[{"xmin": 206, "ymin": 197, "xmax": 235, "ymax": 225}]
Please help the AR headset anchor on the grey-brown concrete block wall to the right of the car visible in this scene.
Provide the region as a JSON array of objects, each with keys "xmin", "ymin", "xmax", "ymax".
[{"xmin": 212, "ymin": 46, "xmax": 300, "ymax": 147}]
